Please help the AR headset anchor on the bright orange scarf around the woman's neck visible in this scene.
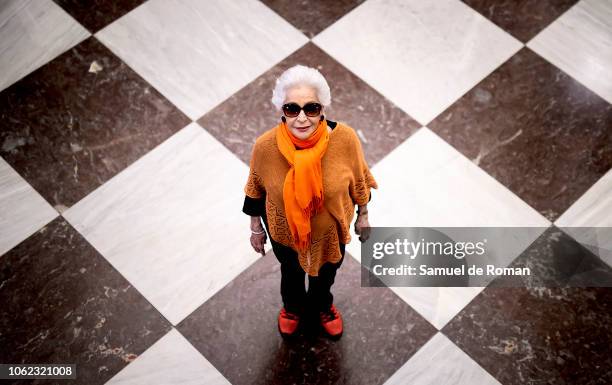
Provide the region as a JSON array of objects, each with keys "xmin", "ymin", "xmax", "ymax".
[{"xmin": 276, "ymin": 119, "xmax": 329, "ymax": 253}]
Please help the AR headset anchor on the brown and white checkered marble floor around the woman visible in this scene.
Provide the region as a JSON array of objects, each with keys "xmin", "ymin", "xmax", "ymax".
[{"xmin": 0, "ymin": 0, "xmax": 612, "ymax": 385}]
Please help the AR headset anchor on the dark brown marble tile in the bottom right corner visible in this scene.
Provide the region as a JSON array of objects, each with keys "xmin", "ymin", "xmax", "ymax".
[{"xmin": 442, "ymin": 226, "xmax": 612, "ymax": 385}]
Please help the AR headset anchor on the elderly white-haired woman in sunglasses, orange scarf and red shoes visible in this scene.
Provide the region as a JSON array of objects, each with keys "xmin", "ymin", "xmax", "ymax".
[{"xmin": 243, "ymin": 65, "xmax": 377, "ymax": 338}]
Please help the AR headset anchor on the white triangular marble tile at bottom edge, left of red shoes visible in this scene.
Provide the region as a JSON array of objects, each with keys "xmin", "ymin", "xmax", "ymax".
[{"xmin": 106, "ymin": 328, "xmax": 230, "ymax": 385}]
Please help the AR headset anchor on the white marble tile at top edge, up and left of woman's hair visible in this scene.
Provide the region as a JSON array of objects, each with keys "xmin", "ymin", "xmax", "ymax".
[{"xmin": 95, "ymin": 0, "xmax": 308, "ymax": 120}]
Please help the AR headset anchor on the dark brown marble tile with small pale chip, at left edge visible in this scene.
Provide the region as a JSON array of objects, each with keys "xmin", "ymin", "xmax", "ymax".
[{"xmin": 0, "ymin": 37, "xmax": 190, "ymax": 212}]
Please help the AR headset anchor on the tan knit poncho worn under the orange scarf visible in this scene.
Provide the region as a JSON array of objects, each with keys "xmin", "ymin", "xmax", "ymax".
[{"xmin": 244, "ymin": 122, "xmax": 378, "ymax": 276}]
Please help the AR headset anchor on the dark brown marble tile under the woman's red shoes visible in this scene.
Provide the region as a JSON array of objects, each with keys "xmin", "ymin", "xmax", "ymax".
[{"xmin": 177, "ymin": 251, "xmax": 436, "ymax": 385}]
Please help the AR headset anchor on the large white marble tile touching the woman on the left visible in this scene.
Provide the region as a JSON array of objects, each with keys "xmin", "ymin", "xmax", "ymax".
[{"xmin": 63, "ymin": 123, "xmax": 258, "ymax": 325}]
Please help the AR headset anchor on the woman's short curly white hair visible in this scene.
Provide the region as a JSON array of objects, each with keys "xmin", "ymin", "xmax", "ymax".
[{"xmin": 271, "ymin": 64, "xmax": 331, "ymax": 111}]
